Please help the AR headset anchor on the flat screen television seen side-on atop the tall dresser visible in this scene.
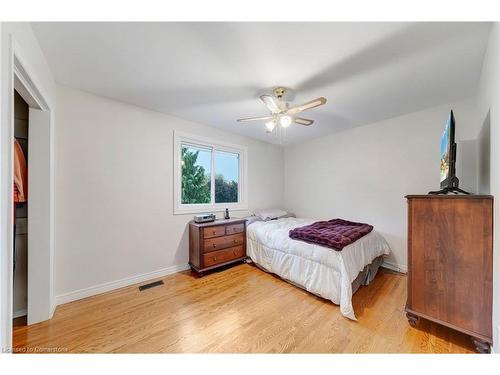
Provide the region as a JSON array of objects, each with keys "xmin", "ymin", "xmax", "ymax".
[{"xmin": 429, "ymin": 111, "xmax": 469, "ymax": 194}]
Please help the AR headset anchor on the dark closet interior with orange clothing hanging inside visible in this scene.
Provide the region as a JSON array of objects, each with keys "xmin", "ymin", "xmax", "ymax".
[{"xmin": 12, "ymin": 90, "xmax": 29, "ymax": 326}]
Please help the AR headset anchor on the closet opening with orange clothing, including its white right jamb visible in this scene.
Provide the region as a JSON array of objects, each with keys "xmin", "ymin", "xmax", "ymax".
[{"xmin": 9, "ymin": 59, "xmax": 54, "ymax": 332}]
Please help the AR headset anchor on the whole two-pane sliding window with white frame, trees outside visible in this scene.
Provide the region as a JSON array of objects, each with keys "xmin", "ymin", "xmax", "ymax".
[{"xmin": 174, "ymin": 132, "xmax": 247, "ymax": 214}]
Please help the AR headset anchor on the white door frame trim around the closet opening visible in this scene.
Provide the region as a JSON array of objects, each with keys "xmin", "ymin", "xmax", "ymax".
[{"xmin": 0, "ymin": 35, "xmax": 55, "ymax": 352}]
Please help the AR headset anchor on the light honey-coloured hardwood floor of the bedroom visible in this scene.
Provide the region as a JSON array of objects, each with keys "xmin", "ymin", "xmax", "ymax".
[{"xmin": 13, "ymin": 264, "xmax": 473, "ymax": 353}]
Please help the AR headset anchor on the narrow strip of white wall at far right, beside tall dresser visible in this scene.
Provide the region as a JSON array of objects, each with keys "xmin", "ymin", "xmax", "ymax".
[{"xmin": 476, "ymin": 23, "xmax": 500, "ymax": 353}]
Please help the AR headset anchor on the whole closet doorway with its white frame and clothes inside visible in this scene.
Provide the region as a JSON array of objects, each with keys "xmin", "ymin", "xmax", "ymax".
[{"xmin": 0, "ymin": 44, "xmax": 55, "ymax": 351}]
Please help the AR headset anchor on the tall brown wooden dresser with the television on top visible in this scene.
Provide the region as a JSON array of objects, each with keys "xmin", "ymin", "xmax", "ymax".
[{"xmin": 406, "ymin": 195, "xmax": 493, "ymax": 352}]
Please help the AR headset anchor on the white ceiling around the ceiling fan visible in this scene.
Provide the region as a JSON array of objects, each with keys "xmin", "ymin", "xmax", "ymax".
[{"xmin": 32, "ymin": 23, "xmax": 490, "ymax": 143}]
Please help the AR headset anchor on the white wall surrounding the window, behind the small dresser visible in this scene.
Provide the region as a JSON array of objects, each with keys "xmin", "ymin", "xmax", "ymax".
[{"xmin": 55, "ymin": 86, "xmax": 283, "ymax": 302}]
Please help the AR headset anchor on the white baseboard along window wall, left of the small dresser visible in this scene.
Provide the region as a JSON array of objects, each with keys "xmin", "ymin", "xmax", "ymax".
[{"xmin": 55, "ymin": 263, "xmax": 189, "ymax": 306}]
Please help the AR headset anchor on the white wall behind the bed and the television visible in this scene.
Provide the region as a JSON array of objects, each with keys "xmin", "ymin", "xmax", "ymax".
[{"xmin": 285, "ymin": 100, "xmax": 476, "ymax": 271}]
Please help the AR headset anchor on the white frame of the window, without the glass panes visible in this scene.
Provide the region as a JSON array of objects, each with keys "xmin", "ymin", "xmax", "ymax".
[{"xmin": 174, "ymin": 131, "xmax": 248, "ymax": 215}]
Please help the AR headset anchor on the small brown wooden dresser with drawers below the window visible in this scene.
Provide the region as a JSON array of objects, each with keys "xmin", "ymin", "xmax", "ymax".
[{"xmin": 189, "ymin": 219, "xmax": 246, "ymax": 275}]
